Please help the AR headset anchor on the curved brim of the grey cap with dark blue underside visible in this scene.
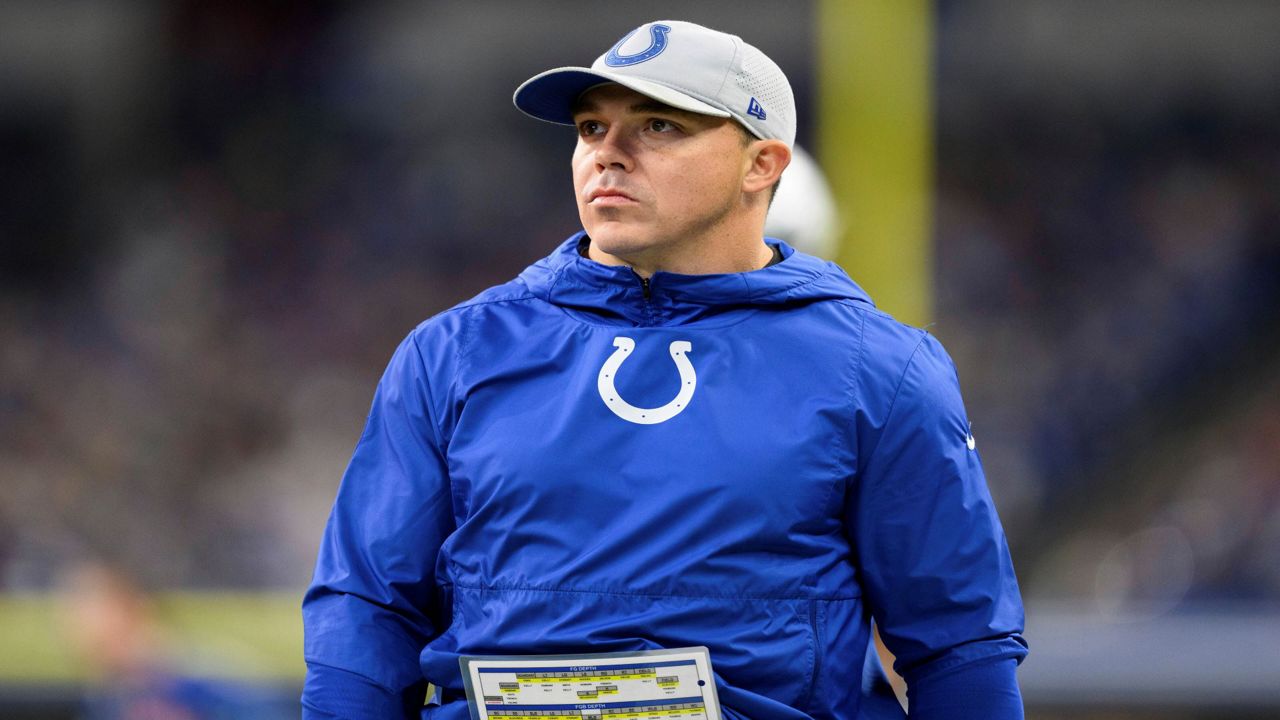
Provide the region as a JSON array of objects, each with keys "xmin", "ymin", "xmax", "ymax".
[{"xmin": 512, "ymin": 68, "xmax": 730, "ymax": 126}]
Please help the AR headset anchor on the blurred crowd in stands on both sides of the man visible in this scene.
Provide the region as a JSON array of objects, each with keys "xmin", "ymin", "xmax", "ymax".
[{"xmin": 0, "ymin": 1, "xmax": 1280, "ymax": 627}]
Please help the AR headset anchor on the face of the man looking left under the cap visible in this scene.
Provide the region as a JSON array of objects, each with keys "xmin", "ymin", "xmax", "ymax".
[{"xmin": 573, "ymin": 85, "xmax": 750, "ymax": 265}]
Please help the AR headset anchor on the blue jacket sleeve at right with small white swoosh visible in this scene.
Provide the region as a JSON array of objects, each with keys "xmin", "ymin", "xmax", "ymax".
[{"xmin": 846, "ymin": 336, "xmax": 1027, "ymax": 720}]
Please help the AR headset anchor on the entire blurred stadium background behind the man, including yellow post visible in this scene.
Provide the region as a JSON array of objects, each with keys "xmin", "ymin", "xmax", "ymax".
[{"xmin": 0, "ymin": 0, "xmax": 1280, "ymax": 720}]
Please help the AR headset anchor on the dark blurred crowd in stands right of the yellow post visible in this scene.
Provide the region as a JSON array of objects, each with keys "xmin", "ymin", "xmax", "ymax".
[{"xmin": 934, "ymin": 100, "xmax": 1280, "ymax": 607}]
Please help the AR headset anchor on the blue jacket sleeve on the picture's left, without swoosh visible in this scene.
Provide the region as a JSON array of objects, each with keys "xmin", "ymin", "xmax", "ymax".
[{"xmin": 302, "ymin": 334, "xmax": 453, "ymax": 719}]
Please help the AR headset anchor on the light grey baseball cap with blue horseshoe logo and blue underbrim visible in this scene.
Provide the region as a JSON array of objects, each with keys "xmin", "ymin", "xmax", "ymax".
[{"xmin": 513, "ymin": 20, "xmax": 796, "ymax": 146}]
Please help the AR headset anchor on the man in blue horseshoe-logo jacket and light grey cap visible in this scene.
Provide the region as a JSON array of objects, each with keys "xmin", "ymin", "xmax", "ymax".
[{"xmin": 303, "ymin": 20, "xmax": 1027, "ymax": 720}]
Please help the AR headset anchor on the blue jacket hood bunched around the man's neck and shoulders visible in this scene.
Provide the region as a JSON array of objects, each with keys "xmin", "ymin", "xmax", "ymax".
[{"xmin": 520, "ymin": 232, "xmax": 874, "ymax": 325}]
